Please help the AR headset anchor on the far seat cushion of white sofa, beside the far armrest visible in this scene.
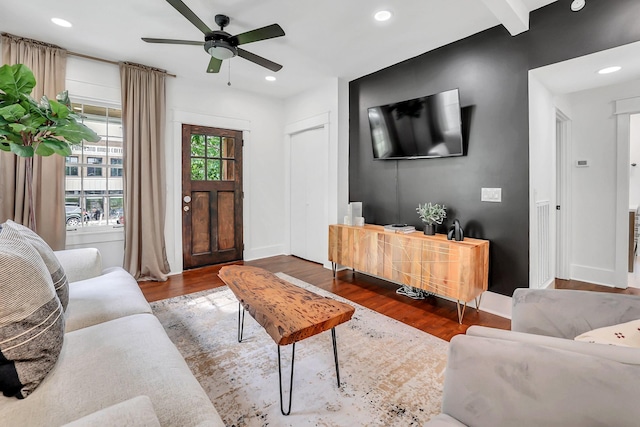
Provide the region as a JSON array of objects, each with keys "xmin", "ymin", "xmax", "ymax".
[{"xmin": 66, "ymin": 267, "xmax": 151, "ymax": 332}]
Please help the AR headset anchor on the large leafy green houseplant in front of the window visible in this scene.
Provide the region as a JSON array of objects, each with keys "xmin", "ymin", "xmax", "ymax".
[{"xmin": 0, "ymin": 64, "xmax": 100, "ymax": 231}]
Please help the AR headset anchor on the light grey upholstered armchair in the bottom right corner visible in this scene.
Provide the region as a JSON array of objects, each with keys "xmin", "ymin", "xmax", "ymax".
[{"xmin": 427, "ymin": 289, "xmax": 640, "ymax": 427}]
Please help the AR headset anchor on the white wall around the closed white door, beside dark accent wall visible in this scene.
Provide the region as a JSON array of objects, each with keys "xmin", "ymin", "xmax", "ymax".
[{"xmin": 284, "ymin": 78, "xmax": 349, "ymax": 268}]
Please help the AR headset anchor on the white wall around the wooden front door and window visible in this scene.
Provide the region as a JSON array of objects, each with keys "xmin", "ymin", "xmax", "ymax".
[{"xmin": 66, "ymin": 57, "xmax": 285, "ymax": 273}]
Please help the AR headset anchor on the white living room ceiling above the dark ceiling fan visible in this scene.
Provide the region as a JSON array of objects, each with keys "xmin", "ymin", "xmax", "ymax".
[{"xmin": 0, "ymin": 0, "xmax": 555, "ymax": 98}]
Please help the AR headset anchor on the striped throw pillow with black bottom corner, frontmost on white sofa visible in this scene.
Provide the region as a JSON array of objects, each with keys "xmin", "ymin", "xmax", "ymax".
[{"xmin": 0, "ymin": 224, "xmax": 64, "ymax": 400}]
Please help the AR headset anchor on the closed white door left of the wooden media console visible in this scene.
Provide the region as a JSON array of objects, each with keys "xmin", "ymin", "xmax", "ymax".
[{"xmin": 290, "ymin": 127, "xmax": 329, "ymax": 264}]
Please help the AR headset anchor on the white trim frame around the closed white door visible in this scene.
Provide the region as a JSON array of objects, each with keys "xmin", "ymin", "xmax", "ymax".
[{"xmin": 284, "ymin": 112, "xmax": 331, "ymax": 268}]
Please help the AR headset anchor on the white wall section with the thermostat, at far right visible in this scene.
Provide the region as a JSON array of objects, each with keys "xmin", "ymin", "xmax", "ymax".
[{"xmin": 565, "ymin": 80, "xmax": 640, "ymax": 286}]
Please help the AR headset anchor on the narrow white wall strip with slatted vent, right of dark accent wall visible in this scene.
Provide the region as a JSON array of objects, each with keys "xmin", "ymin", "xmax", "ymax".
[{"xmin": 529, "ymin": 71, "xmax": 556, "ymax": 288}]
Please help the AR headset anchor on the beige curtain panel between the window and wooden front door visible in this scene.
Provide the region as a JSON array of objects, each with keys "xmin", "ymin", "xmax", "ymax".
[{"xmin": 120, "ymin": 63, "xmax": 170, "ymax": 281}]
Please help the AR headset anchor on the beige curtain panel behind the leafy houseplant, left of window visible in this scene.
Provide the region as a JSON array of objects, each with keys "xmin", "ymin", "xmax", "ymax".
[{"xmin": 0, "ymin": 34, "xmax": 67, "ymax": 250}]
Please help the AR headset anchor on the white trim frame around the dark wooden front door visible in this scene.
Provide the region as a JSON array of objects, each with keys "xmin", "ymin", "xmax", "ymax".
[{"xmin": 165, "ymin": 109, "xmax": 253, "ymax": 274}]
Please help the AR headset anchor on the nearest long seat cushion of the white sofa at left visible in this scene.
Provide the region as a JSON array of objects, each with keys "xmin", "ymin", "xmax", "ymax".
[{"xmin": 0, "ymin": 314, "xmax": 224, "ymax": 427}]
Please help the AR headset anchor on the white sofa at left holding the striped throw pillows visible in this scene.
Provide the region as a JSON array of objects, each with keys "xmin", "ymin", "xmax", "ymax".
[{"xmin": 0, "ymin": 249, "xmax": 224, "ymax": 427}]
